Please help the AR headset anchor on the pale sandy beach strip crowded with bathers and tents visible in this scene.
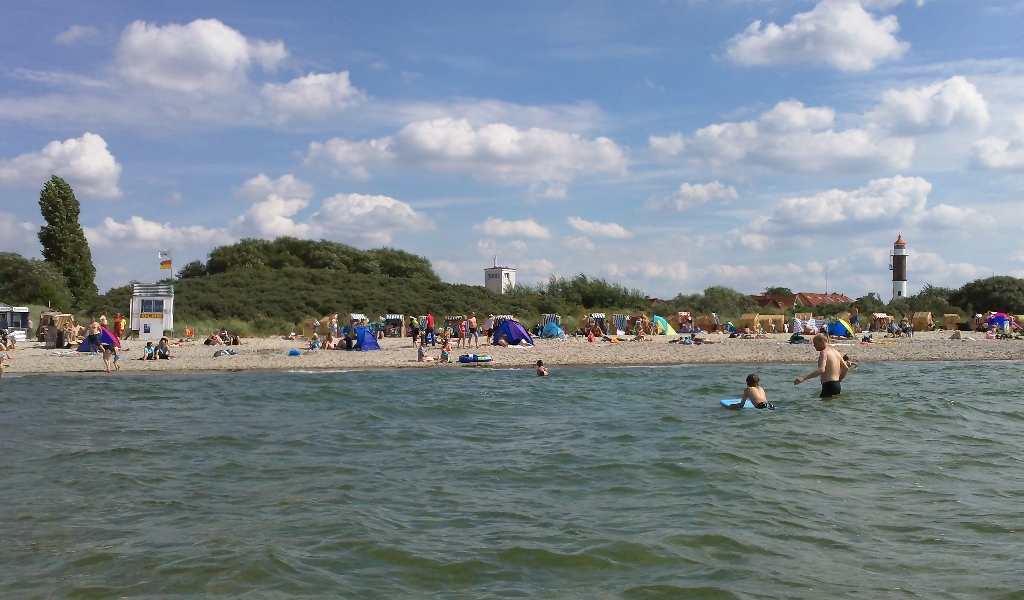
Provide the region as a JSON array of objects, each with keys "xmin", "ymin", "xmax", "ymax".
[{"xmin": 4, "ymin": 331, "xmax": 1024, "ymax": 374}]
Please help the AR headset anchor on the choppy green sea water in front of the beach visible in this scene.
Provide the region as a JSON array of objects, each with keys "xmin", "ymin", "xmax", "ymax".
[{"xmin": 0, "ymin": 362, "xmax": 1024, "ymax": 599}]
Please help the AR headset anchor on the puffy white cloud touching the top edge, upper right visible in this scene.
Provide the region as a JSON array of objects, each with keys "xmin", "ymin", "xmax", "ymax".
[{"xmin": 728, "ymin": 0, "xmax": 910, "ymax": 71}]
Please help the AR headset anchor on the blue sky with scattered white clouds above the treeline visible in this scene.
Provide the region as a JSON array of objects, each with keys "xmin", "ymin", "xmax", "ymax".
[{"xmin": 0, "ymin": 0, "xmax": 1024, "ymax": 300}]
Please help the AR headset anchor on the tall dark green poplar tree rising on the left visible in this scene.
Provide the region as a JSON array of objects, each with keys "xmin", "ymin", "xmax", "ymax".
[{"xmin": 39, "ymin": 175, "xmax": 97, "ymax": 306}]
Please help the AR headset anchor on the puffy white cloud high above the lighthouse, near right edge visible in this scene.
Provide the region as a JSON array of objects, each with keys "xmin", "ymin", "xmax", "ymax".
[{"xmin": 867, "ymin": 76, "xmax": 991, "ymax": 134}]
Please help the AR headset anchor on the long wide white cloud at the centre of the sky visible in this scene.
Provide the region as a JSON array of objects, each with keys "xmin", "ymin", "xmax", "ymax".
[{"xmin": 306, "ymin": 118, "xmax": 626, "ymax": 188}]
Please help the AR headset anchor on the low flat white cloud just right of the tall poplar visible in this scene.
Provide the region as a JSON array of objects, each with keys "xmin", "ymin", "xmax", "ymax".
[{"xmin": 83, "ymin": 216, "xmax": 226, "ymax": 249}]
